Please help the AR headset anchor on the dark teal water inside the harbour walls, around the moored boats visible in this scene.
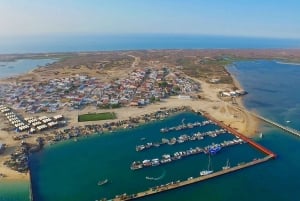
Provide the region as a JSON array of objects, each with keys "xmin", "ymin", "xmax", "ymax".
[{"xmin": 30, "ymin": 113, "xmax": 263, "ymax": 201}]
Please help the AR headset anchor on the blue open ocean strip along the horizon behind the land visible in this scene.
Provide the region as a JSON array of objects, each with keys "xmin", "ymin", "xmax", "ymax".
[{"xmin": 0, "ymin": 34, "xmax": 300, "ymax": 54}]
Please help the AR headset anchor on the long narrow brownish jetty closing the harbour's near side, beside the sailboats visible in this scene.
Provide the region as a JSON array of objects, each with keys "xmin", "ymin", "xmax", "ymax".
[{"xmin": 106, "ymin": 155, "xmax": 273, "ymax": 201}]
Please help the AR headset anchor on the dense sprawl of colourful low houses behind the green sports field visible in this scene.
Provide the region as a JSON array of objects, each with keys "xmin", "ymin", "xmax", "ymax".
[{"xmin": 0, "ymin": 67, "xmax": 201, "ymax": 114}]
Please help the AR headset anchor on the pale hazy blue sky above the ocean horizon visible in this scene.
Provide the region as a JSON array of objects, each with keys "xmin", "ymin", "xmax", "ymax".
[{"xmin": 0, "ymin": 0, "xmax": 300, "ymax": 38}]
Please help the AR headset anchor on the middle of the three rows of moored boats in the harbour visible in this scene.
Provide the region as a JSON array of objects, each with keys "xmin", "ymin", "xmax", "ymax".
[{"xmin": 135, "ymin": 129, "xmax": 227, "ymax": 151}]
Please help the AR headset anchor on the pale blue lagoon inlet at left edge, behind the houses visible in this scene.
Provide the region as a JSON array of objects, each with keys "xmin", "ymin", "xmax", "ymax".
[{"xmin": 0, "ymin": 59, "xmax": 56, "ymax": 79}]
